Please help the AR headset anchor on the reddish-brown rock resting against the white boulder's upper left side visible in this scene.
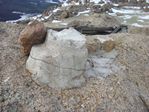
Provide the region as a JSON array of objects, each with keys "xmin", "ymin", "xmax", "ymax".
[{"xmin": 18, "ymin": 21, "xmax": 47, "ymax": 55}]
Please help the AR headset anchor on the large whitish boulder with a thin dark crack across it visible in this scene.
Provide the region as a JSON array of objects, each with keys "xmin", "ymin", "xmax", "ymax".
[{"xmin": 26, "ymin": 28, "xmax": 88, "ymax": 89}]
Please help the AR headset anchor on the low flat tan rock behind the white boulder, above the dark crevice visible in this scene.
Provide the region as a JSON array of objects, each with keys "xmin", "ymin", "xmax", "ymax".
[{"xmin": 44, "ymin": 14, "xmax": 120, "ymax": 28}]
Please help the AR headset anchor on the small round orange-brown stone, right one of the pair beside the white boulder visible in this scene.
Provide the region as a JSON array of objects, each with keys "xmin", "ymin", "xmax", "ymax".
[{"xmin": 102, "ymin": 40, "xmax": 115, "ymax": 52}]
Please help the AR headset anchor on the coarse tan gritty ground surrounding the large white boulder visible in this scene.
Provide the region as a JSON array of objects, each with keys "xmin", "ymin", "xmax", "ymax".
[{"xmin": 0, "ymin": 23, "xmax": 149, "ymax": 112}]
